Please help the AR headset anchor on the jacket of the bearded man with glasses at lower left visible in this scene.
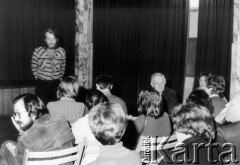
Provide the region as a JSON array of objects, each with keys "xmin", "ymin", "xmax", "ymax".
[{"xmin": 15, "ymin": 114, "xmax": 74, "ymax": 164}]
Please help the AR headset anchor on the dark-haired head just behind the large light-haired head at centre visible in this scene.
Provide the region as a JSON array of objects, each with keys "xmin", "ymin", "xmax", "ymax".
[{"xmin": 85, "ymin": 89, "xmax": 108, "ymax": 110}]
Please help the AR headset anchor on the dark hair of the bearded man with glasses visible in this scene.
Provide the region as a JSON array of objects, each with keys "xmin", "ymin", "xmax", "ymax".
[{"xmin": 12, "ymin": 93, "xmax": 48, "ymax": 119}]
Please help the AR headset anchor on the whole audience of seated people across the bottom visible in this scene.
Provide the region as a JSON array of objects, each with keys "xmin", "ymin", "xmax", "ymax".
[{"xmin": 0, "ymin": 72, "xmax": 240, "ymax": 165}]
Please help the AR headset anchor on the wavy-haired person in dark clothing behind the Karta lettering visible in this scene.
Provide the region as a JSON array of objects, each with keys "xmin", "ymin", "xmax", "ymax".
[{"xmin": 159, "ymin": 104, "xmax": 222, "ymax": 165}]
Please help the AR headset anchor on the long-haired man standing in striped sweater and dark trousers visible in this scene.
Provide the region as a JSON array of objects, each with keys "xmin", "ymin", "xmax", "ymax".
[{"xmin": 31, "ymin": 28, "xmax": 66, "ymax": 105}]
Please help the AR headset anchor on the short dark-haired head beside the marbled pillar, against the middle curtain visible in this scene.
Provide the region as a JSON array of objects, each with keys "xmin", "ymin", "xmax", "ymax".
[{"xmin": 95, "ymin": 74, "xmax": 113, "ymax": 89}]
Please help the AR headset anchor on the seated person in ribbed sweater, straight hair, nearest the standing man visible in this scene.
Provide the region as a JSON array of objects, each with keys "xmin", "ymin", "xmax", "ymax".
[{"xmin": 47, "ymin": 76, "xmax": 88, "ymax": 123}]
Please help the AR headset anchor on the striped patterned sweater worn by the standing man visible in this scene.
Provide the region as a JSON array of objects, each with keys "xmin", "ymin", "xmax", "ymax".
[{"xmin": 31, "ymin": 47, "xmax": 66, "ymax": 80}]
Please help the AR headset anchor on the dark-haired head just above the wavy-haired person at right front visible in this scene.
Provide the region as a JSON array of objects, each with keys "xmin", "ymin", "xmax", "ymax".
[{"xmin": 186, "ymin": 89, "xmax": 213, "ymax": 114}]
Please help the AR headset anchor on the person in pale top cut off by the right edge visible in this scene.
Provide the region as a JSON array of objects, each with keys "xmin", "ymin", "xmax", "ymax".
[{"xmin": 215, "ymin": 92, "xmax": 240, "ymax": 160}]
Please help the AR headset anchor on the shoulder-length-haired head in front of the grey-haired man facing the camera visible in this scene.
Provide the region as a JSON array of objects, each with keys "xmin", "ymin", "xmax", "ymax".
[{"xmin": 138, "ymin": 89, "xmax": 162, "ymax": 118}]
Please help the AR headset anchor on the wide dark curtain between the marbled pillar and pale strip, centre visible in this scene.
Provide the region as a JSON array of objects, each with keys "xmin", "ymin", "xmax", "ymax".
[{"xmin": 93, "ymin": 0, "xmax": 188, "ymax": 111}]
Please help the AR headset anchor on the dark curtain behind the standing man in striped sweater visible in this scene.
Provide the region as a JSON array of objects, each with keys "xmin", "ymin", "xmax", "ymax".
[{"xmin": 0, "ymin": 0, "xmax": 76, "ymax": 81}]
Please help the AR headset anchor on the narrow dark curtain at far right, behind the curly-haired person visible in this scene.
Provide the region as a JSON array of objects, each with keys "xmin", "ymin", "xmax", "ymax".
[{"xmin": 196, "ymin": 0, "xmax": 234, "ymax": 98}]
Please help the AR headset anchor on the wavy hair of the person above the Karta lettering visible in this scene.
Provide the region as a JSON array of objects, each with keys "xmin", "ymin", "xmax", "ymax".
[{"xmin": 172, "ymin": 103, "xmax": 215, "ymax": 141}]
